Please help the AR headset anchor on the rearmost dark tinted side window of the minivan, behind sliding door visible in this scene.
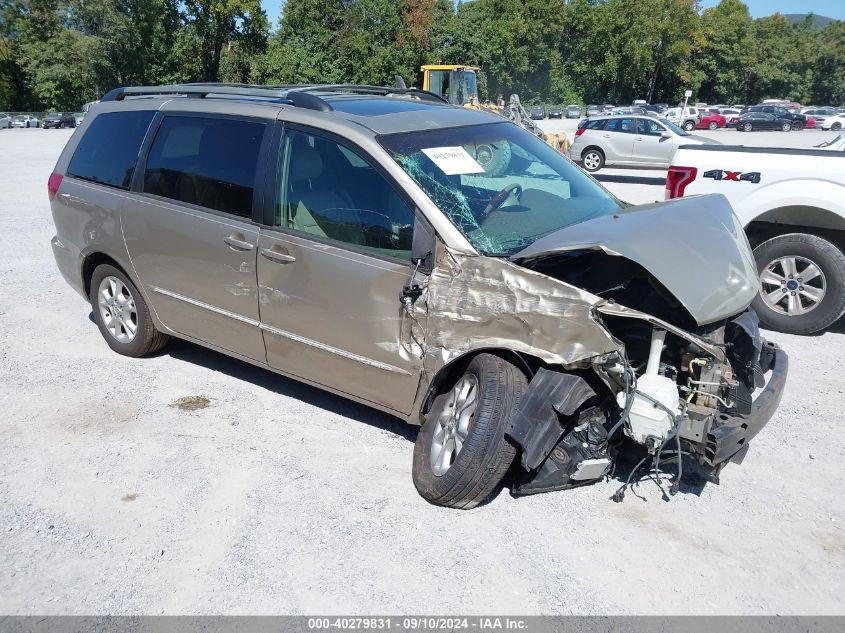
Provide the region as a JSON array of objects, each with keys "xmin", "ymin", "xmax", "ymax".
[{"xmin": 67, "ymin": 111, "xmax": 155, "ymax": 189}]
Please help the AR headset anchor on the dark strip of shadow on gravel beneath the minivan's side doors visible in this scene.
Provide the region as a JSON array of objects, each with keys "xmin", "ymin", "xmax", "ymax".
[{"xmin": 160, "ymin": 339, "xmax": 417, "ymax": 442}]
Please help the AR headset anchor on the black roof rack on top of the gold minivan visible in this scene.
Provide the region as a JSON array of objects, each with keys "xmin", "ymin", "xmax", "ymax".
[{"xmin": 100, "ymin": 83, "xmax": 448, "ymax": 112}]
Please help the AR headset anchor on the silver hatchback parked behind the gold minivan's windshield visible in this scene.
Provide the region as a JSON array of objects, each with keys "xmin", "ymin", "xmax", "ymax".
[{"xmin": 569, "ymin": 115, "xmax": 719, "ymax": 172}]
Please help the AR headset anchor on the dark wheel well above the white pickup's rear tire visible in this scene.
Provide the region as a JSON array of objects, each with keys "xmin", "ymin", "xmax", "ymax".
[{"xmin": 745, "ymin": 212, "xmax": 845, "ymax": 250}]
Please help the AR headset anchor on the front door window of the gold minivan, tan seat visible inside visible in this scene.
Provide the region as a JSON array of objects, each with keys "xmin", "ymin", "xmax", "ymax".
[{"xmin": 276, "ymin": 131, "xmax": 414, "ymax": 260}]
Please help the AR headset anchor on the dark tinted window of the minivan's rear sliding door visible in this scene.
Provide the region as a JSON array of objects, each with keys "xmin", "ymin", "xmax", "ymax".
[{"xmin": 143, "ymin": 116, "xmax": 265, "ymax": 218}]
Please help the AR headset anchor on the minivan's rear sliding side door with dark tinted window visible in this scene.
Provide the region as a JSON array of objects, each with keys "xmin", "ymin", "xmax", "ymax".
[{"xmin": 123, "ymin": 112, "xmax": 272, "ymax": 362}]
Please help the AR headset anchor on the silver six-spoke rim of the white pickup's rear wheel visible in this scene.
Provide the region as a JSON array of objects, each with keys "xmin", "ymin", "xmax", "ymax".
[{"xmin": 760, "ymin": 256, "xmax": 827, "ymax": 316}]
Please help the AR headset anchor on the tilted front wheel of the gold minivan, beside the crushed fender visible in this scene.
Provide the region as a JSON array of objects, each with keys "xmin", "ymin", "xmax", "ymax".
[{"xmin": 413, "ymin": 354, "xmax": 527, "ymax": 509}]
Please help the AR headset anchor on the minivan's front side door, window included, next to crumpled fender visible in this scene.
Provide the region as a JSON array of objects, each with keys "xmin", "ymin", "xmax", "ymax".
[{"xmin": 251, "ymin": 124, "xmax": 423, "ymax": 414}]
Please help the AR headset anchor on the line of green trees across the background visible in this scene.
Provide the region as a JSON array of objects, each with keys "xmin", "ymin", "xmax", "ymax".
[{"xmin": 0, "ymin": 0, "xmax": 845, "ymax": 111}]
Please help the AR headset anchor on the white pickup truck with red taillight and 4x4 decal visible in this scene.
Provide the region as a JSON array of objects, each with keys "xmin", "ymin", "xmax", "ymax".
[{"xmin": 666, "ymin": 134, "xmax": 845, "ymax": 334}]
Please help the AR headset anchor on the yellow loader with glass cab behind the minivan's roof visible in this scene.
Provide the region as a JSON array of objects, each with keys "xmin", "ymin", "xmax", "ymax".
[{"xmin": 420, "ymin": 64, "xmax": 570, "ymax": 154}]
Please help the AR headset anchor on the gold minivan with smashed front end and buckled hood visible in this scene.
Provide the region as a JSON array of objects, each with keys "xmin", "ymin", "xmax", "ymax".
[{"xmin": 48, "ymin": 84, "xmax": 787, "ymax": 508}]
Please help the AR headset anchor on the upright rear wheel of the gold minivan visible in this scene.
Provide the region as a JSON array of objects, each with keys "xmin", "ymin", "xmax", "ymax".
[{"xmin": 88, "ymin": 264, "xmax": 170, "ymax": 358}]
